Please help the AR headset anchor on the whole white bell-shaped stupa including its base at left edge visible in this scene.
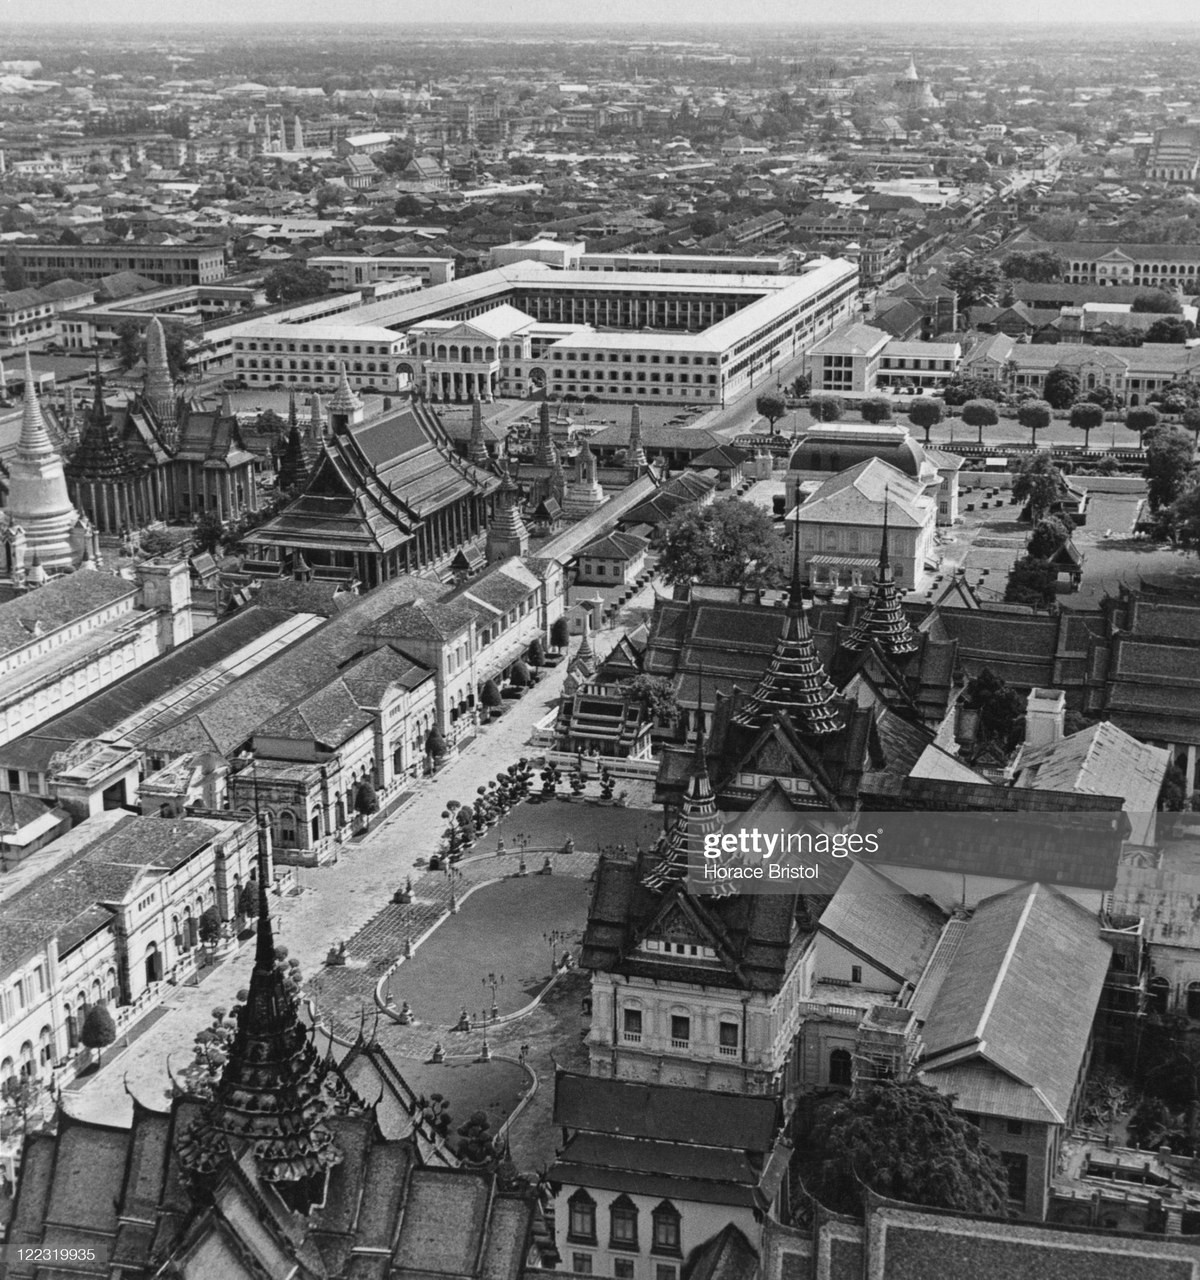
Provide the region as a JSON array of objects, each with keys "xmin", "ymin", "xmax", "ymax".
[{"xmin": 0, "ymin": 355, "xmax": 88, "ymax": 586}]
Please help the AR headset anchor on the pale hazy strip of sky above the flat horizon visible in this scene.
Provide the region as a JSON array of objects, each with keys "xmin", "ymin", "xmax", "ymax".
[{"xmin": 7, "ymin": 0, "xmax": 1200, "ymax": 25}]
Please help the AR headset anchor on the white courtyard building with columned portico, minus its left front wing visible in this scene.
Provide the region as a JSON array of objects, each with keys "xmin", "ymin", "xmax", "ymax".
[{"xmin": 373, "ymin": 259, "xmax": 858, "ymax": 404}]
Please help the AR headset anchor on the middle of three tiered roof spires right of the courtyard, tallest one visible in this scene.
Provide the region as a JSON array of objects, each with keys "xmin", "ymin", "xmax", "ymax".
[{"xmin": 734, "ymin": 524, "xmax": 842, "ymax": 737}]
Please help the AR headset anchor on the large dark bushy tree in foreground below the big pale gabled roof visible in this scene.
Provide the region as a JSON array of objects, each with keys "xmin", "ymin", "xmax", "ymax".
[{"xmin": 798, "ymin": 1080, "xmax": 1008, "ymax": 1215}]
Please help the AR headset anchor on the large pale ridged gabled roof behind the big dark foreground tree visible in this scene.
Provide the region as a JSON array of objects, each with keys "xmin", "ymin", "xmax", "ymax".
[{"xmin": 921, "ymin": 884, "xmax": 1112, "ymax": 1124}]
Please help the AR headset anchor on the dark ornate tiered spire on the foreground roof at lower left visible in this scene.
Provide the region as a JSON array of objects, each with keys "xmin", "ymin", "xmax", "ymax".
[{"xmin": 179, "ymin": 817, "xmax": 343, "ymax": 1212}]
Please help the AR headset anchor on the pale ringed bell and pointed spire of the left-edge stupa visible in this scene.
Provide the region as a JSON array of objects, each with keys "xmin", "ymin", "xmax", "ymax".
[{"xmin": 8, "ymin": 352, "xmax": 79, "ymax": 568}]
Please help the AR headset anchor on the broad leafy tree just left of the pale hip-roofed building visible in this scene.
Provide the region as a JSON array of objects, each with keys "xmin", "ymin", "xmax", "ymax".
[{"xmin": 655, "ymin": 498, "xmax": 786, "ymax": 588}]
